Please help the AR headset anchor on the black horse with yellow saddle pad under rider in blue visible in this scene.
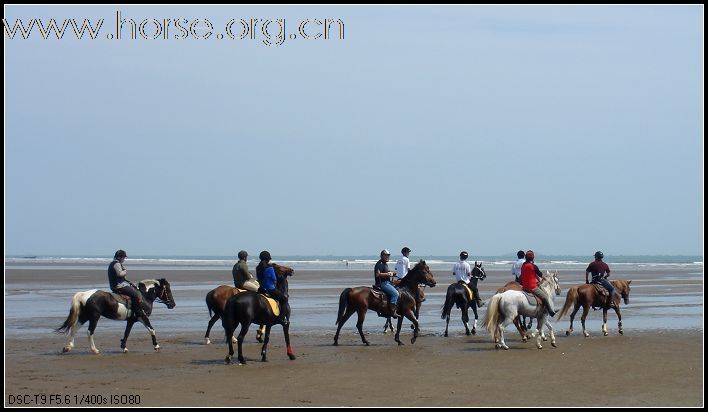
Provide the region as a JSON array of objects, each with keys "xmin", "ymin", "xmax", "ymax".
[{"xmin": 221, "ymin": 264, "xmax": 295, "ymax": 365}]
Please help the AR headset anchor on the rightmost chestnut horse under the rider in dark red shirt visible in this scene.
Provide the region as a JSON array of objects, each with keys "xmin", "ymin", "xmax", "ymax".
[{"xmin": 558, "ymin": 279, "xmax": 632, "ymax": 338}]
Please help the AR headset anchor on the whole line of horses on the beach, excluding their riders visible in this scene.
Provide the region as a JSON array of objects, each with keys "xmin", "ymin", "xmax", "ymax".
[{"xmin": 57, "ymin": 260, "xmax": 631, "ymax": 364}]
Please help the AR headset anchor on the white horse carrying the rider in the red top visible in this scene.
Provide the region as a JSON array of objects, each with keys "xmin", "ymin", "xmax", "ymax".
[{"xmin": 483, "ymin": 271, "xmax": 561, "ymax": 349}]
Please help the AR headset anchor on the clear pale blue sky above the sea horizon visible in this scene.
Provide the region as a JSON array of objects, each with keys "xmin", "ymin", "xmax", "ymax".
[{"xmin": 4, "ymin": 5, "xmax": 704, "ymax": 257}]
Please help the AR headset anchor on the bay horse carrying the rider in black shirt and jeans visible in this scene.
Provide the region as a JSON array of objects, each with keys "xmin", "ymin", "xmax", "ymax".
[{"xmin": 334, "ymin": 259, "xmax": 435, "ymax": 346}]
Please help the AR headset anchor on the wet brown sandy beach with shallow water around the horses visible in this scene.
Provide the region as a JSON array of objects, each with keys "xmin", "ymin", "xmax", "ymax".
[{"xmin": 5, "ymin": 268, "xmax": 703, "ymax": 407}]
